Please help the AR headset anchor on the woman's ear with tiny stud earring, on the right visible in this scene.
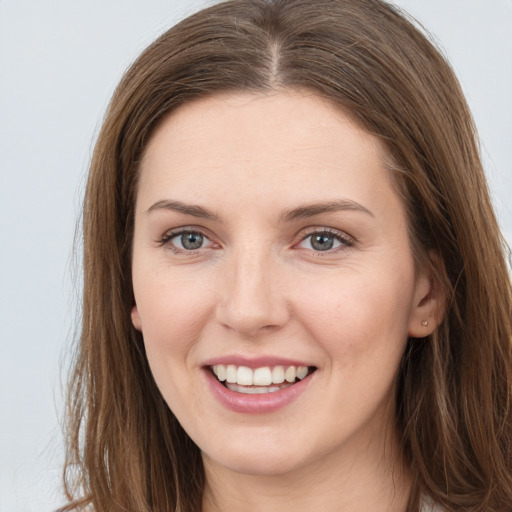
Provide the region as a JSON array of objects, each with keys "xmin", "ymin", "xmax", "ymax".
[{"xmin": 409, "ymin": 252, "xmax": 446, "ymax": 338}]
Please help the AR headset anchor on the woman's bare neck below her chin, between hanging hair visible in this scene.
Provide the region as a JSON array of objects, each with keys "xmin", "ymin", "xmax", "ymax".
[{"xmin": 203, "ymin": 428, "xmax": 411, "ymax": 512}]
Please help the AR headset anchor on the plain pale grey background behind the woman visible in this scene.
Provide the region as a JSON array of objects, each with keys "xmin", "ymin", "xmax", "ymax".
[{"xmin": 0, "ymin": 0, "xmax": 512, "ymax": 512}]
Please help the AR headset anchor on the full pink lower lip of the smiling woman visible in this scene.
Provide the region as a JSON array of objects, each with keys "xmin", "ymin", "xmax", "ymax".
[{"xmin": 205, "ymin": 369, "xmax": 313, "ymax": 414}]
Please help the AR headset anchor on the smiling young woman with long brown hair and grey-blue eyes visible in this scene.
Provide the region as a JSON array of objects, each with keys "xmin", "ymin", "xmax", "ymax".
[{"xmin": 62, "ymin": 0, "xmax": 512, "ymax": 512}]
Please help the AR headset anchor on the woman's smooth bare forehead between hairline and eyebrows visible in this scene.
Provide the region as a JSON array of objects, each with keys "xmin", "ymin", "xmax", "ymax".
[{"xmin": 138, "ymin": 91, "xmax": 398, "ymax": 218}]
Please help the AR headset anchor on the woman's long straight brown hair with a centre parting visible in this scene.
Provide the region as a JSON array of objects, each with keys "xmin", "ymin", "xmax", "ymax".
[{"xmin": 62, "ymin": 0, "xmax": 512, "ymax": 512}]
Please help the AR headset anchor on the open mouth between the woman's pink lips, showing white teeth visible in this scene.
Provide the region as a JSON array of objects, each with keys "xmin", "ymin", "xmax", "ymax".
[{"xmin": 209, "ymin": 364, "xmax": 316, "ymax": 394}]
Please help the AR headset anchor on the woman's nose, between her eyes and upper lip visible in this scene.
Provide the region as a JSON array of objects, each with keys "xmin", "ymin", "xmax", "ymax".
[{"xmin": 217, "ymin": 248, "xmax": 290, "ymax": 337}]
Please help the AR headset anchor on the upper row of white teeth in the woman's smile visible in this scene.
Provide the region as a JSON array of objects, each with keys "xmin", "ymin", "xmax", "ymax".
[{"xmin": 212, "ymin": 364, "xmax": 309, "ymax": 386}]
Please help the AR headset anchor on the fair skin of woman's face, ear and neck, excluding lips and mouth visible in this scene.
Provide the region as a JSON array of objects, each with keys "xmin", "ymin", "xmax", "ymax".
[{"xmin": 132, "ymin": 91, "xmax": 437, "ymax": 512}]
